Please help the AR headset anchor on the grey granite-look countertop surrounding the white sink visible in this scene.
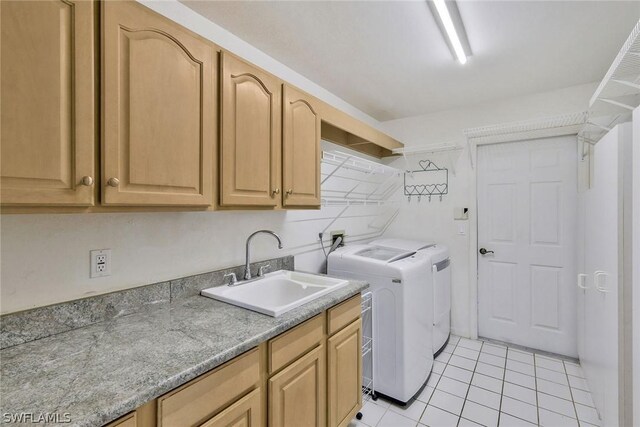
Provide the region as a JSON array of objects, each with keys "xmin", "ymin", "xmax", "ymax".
[{"xmin": 0, "ymin": 281, "xmax": 368, "ymax": 426}]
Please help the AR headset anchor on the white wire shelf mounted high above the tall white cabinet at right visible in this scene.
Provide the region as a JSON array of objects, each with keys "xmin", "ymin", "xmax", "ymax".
[{"xmin": 578, "ymin": 20, "xmax": 640, "ymax": 146}]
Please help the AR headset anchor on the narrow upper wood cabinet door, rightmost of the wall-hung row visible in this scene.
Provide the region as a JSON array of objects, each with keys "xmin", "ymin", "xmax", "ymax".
[{"xmin": 282, "ymin": 84, "xmax": 320, "ymax": 207}]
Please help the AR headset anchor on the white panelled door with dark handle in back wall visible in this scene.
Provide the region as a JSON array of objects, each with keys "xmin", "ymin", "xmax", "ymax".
[{"xmin": 478, "ymin": 136, "xmax": 577, "ymax": 357}]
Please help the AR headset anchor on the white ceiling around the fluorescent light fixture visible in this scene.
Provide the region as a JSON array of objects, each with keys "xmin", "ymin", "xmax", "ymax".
[{"xmin": 182, "ymin": 0, "xmax": 640, "ymax": 121}]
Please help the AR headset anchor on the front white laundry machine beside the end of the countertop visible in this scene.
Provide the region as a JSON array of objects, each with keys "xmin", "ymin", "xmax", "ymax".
[{"xmin": 328, "ymin": 245, "xmax": 433, "ymax": 403}]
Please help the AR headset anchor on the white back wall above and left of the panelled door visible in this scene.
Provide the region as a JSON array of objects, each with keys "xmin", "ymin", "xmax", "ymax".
[{"xmin": 382, "ymin": 83, "xmax": 597, "ymax": 336}]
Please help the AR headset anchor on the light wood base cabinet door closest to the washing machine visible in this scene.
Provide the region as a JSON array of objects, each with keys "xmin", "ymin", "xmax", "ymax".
[{"xmin": 327, "ymin": 319, "xmax": 362, "ymax": 427}]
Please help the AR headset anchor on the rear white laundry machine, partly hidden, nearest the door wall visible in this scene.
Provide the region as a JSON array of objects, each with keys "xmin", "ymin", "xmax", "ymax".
[{"xmin": 370, "ymin": 239, "xmax": 451, "ymax": 355}]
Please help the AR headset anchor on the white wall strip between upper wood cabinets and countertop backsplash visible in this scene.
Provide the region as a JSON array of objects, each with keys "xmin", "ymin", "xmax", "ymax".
[{"xmin": 0, "ymin": 197, "xmax": 396, "ymax": 313}]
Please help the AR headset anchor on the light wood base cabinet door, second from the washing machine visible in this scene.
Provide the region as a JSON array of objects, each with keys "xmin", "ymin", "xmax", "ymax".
[{"xmin": 269, "ymin": 345, "xmax": 326, "ymax": 427}]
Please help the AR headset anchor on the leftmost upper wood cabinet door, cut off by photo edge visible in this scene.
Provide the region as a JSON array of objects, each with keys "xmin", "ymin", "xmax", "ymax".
[{"xmin": 0, "ymin": 0, "xmax": 96, "ymax": 206}]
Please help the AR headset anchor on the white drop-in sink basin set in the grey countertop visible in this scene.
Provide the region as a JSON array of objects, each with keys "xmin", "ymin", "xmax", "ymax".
[{"xmin": 200, "ymin": 270, "xmax": 349, "ymax": 317}]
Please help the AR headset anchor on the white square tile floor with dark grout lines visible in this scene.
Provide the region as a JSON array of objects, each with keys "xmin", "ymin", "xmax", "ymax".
[{"xmin": 350, "ymin": 336, "xmax": 600, "ymax": 427}]
